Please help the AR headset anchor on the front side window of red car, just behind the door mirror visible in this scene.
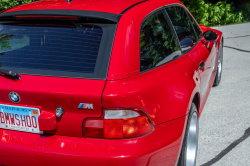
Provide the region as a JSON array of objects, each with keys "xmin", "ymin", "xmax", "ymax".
[{"xmin": 166, "ymin": 6, "xmax": 197, "ymax": 53}]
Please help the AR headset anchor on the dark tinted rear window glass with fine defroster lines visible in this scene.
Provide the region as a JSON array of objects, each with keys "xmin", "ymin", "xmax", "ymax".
[{"xmin": 0, "ymin": 21, "xmax": 115, "ymax": 78}]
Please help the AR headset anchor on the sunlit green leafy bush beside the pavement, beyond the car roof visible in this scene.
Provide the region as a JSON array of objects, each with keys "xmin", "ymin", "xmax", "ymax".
[{"xmin": 181, "ymin": 0, "xmax": 243, "ymax": 26}]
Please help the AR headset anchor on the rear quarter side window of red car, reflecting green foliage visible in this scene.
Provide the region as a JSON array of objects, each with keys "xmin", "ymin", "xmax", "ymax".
[{"xmin": 140, "ymin": 11, "xmax": 181, "ymax": 71}]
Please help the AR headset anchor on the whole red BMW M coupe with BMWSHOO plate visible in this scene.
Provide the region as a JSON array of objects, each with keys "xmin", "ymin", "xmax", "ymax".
[{"xmin": 0, "ymin": 0, "xmax": 223, "ymax": 166}]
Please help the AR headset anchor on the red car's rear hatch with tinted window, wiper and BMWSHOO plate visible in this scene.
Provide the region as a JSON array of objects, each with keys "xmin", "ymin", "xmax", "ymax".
[{"xmin": 0, "ymin": 15, "xmax": 116, "ymax": 137}]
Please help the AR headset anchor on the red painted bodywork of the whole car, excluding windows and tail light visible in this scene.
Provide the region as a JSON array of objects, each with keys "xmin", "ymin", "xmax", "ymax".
[{"xmin": 0, "ymin": 0, "xmax": 223, "ymax": 166}]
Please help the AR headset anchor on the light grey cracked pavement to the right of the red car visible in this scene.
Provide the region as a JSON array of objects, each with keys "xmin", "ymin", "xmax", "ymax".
[{"xmin": 196, "ymin": 23, "xmax": 250, "ymax": 166}]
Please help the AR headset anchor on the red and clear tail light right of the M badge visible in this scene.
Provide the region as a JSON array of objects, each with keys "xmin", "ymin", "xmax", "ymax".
[{"xmin": 83, "ymin": 109, "xmax": 153, "ymax": 139}]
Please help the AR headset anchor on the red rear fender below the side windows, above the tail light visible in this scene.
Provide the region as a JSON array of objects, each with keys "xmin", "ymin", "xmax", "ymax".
[{"xmin": 103, "ymin": 55, "xmax": 199, "ymax": 125}]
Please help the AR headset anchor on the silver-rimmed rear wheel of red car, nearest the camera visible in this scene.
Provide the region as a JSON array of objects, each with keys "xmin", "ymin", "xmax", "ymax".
[{"xmin": 178, "ymin": 103, "xmax": 199, "ymax": 166}]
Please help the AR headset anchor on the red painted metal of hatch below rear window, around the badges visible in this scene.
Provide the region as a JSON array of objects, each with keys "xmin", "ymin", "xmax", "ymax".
[{"xmin": 0, "ymin": 75, "xmax": 105, "ymax": 137}]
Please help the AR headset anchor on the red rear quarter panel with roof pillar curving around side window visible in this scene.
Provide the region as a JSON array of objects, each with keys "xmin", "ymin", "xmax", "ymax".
[{"xmin": 102, "ymin": 0, "xmax": 199, "ymax": 125}]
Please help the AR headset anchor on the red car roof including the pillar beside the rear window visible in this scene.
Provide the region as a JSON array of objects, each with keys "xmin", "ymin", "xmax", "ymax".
[{"xmin": 0, "ymin": 0, "xmax": 186, "ymax": 80}]
